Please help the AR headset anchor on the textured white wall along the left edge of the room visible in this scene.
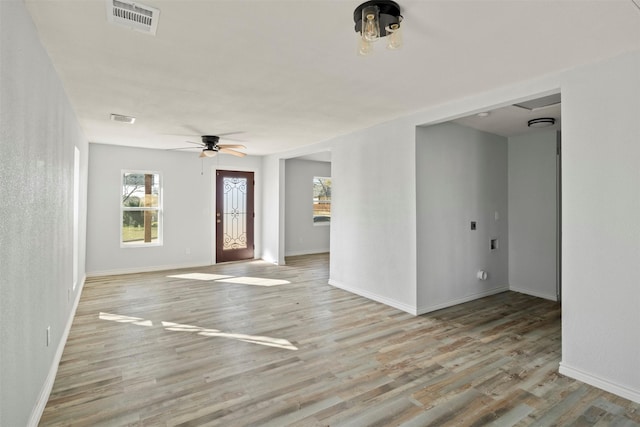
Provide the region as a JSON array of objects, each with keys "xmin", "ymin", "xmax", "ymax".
[{"xmin": 0, "ymin": 0, "xmax": 88, "ymax": 426}]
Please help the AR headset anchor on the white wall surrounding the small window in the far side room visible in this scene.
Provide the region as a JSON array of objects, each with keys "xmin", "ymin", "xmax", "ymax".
[{"xmin": 285, "ymin": 159, "xmax": 331, "ymax": 256}]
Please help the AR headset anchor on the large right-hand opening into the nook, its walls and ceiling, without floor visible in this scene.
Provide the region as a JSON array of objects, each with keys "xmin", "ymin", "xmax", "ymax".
[{"xmin": 416, "ymin": 93, "xmax": 561, "ymax": 313}]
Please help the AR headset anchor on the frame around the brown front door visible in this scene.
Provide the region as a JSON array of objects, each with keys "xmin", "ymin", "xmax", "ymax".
[{"xmin": 209, "ymin": 164, "xmax": 261, "ymax": 265}]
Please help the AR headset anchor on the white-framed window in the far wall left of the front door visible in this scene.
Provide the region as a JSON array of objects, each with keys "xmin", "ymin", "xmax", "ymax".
[{"xmin": 120, "ymin": 171, "xmax": 162, "ymax": 247}]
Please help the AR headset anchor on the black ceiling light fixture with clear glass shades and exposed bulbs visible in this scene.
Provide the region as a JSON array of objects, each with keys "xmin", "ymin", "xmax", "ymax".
[{"xmin": 353, "ymin": 0, "xmax": 402, "ymax": 56}]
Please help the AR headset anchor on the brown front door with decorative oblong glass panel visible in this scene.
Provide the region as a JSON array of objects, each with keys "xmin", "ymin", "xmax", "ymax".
[{"xmin": 216, "ymin": 170, "xmax": 255, "ymax": 263}]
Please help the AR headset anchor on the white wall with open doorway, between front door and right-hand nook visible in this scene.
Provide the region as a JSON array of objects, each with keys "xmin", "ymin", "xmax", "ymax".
[{"xmin": 263, "ymin": 120, "xmax": 416, "ymax": 313}]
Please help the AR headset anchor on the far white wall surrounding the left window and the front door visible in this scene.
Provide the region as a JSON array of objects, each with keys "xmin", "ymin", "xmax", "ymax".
[{"xmin": 87, "ymin": 144, "xmax": 262, "ymax": 275}]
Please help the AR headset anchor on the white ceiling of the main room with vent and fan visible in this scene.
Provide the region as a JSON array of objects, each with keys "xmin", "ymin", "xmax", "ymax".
[{"xmin": 25, "ymin": 0, "xmax": 640, "ymax": 155}]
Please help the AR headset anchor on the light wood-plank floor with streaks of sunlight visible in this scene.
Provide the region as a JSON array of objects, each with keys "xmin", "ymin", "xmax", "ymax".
[{"xmin": 40, "ymin": 255, "xmax": 640, "ymax": 426}]
